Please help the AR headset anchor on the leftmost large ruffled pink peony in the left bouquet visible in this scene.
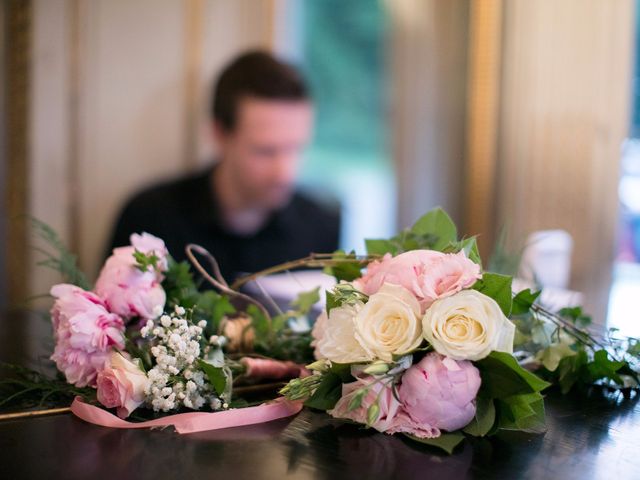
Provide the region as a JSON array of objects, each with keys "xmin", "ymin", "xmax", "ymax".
[{"xmin": 51, "ymin": 284, "xmax": 124, "ymax": 387}]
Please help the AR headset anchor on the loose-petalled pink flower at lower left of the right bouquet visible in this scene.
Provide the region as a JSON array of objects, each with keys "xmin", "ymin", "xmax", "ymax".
[{"xmin": 327, "ymin": 376, "xmax": 440, "ymax": 438}]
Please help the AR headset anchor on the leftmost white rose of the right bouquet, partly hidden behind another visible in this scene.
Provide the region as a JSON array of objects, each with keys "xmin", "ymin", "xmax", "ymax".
[{"xmin": 312, "ymin": 302, "xmax": 371, "ymax": 363}]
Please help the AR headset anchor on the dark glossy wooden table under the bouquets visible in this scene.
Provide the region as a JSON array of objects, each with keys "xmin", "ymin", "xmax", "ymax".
[{"xmin": 0, "ymin": 315, "xmax": 640, "ymax": 480}]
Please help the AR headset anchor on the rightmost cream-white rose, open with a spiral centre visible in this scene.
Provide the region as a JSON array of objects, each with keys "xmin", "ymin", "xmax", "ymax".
[{"xmin": 422, "ymin": 290, "xmax": 516, "ymax": 360}]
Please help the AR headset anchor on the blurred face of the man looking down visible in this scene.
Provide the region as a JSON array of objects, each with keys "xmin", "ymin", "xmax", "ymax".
[{"xmin": 216, "ymin": 98, "xmax": 313, "ymax": 209}]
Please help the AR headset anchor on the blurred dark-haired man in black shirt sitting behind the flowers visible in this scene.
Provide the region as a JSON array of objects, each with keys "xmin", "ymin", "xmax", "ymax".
[{"xmin": 111, "ymin": 51, "xmax": 340, "ymax": 281}]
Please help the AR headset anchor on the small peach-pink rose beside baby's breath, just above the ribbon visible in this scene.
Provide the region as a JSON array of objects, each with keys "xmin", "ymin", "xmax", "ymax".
[{"xmin": 97, "ymin": 352, "xmax": 149, "ymax": 418}]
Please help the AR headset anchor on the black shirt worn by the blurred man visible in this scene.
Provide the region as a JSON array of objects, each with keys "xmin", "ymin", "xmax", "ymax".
[{"xmin": 109, "ymin": 168, "xmax": 340, "ymax": 281}]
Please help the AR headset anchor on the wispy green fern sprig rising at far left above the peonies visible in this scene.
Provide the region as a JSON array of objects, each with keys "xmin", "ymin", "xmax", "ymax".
[{"xmin": 31, "ymin": 218, "xmax": 91, "ymax": 290}]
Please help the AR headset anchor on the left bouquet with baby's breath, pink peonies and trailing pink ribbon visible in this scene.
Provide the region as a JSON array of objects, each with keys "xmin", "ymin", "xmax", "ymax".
[{"xmin": 0, "ymin": 222, "xmax": 317, "ymax": 432}]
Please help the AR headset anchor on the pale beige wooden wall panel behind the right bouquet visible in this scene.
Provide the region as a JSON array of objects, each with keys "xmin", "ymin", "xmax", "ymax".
[{"xmin": 497, "ymin": 0, "xmax": 634, "ymax": 316}]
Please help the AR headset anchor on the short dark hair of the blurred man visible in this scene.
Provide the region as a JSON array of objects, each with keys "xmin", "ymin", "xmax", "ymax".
[{"xmin": 210, "ymin": 50, "xmax": 309, "ymax": 130}]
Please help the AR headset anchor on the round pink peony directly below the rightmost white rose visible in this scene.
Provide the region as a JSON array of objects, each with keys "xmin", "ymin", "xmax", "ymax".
[{"xmin": 398, "ymin": 352, "xmax": 480, "ymax": 432}]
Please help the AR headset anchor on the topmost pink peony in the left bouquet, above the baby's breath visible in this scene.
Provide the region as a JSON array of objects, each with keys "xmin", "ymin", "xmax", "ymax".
[{"xmin": 95, "ymin": 233, "xmax": 168, "ymax": 319}]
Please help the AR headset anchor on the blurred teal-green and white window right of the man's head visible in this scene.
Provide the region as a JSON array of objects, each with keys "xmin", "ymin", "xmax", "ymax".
[{"xmin": 276, "ymin": 0, "xmax": 396, "ymax": 252}]
